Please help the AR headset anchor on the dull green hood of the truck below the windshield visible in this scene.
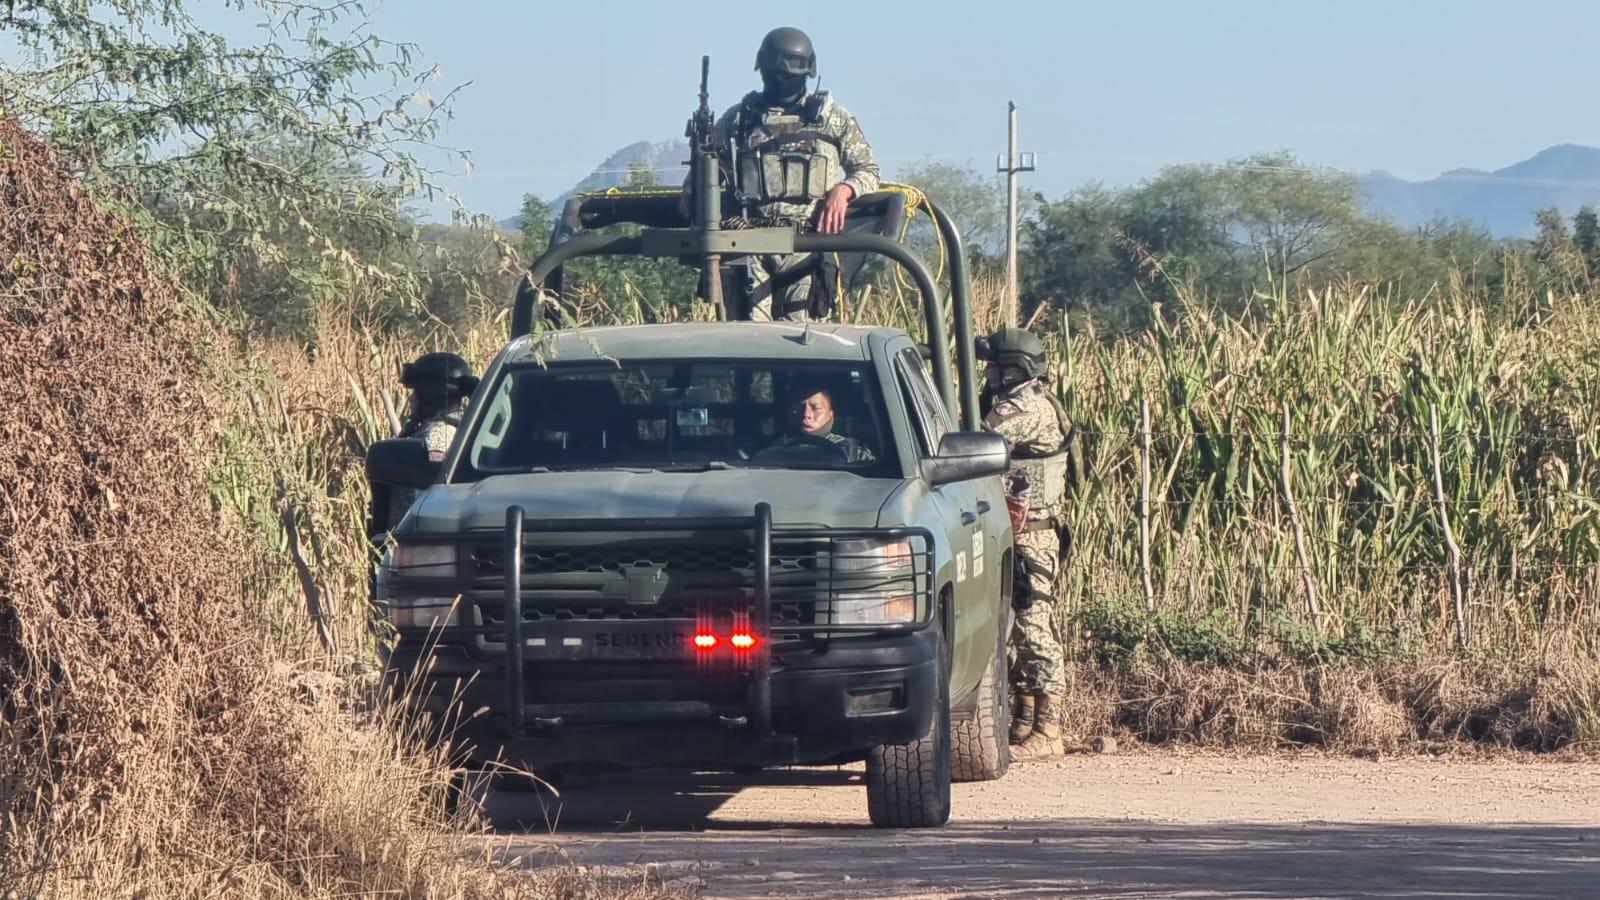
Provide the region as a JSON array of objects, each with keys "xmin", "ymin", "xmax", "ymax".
[{"xmin": 402, "ymin": 469, "xmax": 904, "ymax": 533}]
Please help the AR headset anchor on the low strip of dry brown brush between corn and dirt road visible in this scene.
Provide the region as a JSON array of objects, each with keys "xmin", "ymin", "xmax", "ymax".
[{"xmin": 1066, "ymin": 646, "xmax": 1600, "ymax": 753}]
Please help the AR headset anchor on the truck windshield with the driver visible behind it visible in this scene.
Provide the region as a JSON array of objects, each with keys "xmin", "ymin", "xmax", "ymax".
[{"xmin": 453, "ymin": 360, "xmax": 890, "ymax": 480}]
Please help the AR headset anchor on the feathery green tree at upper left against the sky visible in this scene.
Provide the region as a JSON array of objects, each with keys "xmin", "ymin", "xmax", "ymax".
[{"xmin": 0, "ymin": 0, "xmax": 486, "ymax": 331}]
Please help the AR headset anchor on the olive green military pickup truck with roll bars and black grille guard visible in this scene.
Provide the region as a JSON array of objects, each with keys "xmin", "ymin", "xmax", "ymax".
[{"xmin": 366, "ymin": 52, "xmax": 1013, "ymax": 828}]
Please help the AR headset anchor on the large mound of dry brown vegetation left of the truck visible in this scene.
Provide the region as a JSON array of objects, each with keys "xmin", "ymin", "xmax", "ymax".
[{"xmin": 0, "ymin": 120, "xmax": 675, "ymax": 898}]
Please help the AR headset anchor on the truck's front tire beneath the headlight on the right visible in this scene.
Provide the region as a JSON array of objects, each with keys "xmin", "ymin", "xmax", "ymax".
[{"xmin": 867, "ymin": 617, "xmax": 950, "ymax": 828}]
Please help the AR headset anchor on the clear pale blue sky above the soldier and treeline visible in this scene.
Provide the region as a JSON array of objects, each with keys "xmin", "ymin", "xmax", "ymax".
[{"xmin": 344, "ymin": 0, "xmax": 1600, "ymax": 216}]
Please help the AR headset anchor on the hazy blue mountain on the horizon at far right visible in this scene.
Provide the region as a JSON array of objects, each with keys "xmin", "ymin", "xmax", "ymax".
[{"xmin": 1358, "ymin": 144, "xmax": 1600, "ymax": 237}]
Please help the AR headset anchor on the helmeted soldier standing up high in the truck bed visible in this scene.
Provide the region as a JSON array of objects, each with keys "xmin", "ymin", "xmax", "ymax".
[{"xmin": 682, "ymin": 27, "xmax": 878, "ymax": 322}]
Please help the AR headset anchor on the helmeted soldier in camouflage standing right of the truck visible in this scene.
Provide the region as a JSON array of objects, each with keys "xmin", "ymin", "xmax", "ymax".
[{"xmin": 978, "ymin": 328, "xmax": 1072, "ymax": 759}]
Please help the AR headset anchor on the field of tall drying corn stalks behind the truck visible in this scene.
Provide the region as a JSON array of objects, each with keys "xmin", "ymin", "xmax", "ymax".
[{"xmin": 229, "ymin": 261, "xmax": 1600, "ymax": 740}]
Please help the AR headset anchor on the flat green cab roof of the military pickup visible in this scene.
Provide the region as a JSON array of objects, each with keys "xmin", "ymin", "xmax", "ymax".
[{"xmin": 506, "ymin": 322, "xmax": 904, "ymax": 364}]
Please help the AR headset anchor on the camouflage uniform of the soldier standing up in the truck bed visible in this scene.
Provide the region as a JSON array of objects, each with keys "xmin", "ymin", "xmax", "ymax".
[{"xmin": 715, "ymin": 91, "xmax": 878, "ymax": 322}]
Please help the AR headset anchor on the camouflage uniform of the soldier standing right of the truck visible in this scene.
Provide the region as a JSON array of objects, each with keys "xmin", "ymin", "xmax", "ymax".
[{"xmin": 984, "ymin": 380, "xmax": 1067, "ymax": 697}]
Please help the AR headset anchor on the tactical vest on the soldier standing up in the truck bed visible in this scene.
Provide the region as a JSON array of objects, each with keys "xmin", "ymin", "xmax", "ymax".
[{"xmin": 733, "ymin": 91, "xmax": 843, "ymax": 205}]
